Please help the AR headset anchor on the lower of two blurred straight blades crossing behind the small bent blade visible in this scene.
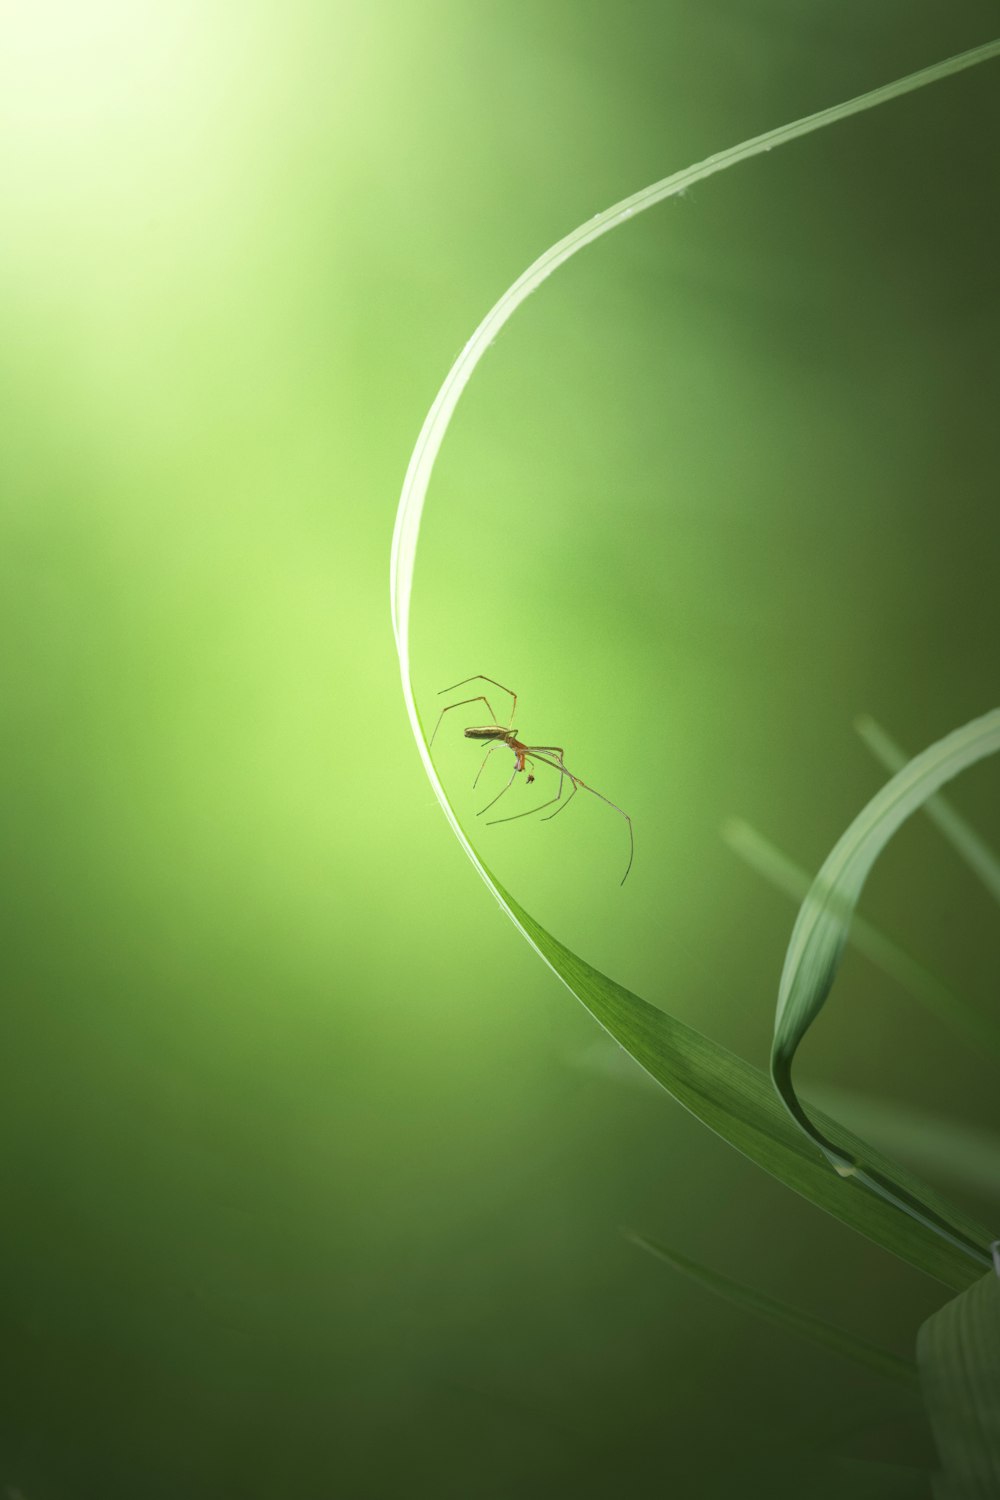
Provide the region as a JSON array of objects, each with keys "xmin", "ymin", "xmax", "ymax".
[{"xmin": 723, "ymin": 818, "xmax": 1000, "ymax": 1056}]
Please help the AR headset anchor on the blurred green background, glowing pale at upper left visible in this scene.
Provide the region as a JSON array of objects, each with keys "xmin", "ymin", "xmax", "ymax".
[{"xmin": 0, "ymin": 0, "xmax": 1000, "ymax": 1500}]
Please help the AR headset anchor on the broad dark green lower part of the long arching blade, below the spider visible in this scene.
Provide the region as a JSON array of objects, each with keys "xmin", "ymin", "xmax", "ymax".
[{"xmin": 497, "ymin": 872, "xmax": 993, "ymax": 1287}]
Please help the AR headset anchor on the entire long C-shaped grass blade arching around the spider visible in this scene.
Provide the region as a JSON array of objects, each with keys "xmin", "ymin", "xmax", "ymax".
[{"xmin": 390, "ymin": 39, "xmax": 1000, "ymax": 1287}]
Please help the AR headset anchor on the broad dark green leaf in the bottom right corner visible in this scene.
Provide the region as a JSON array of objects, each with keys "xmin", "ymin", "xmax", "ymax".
[{"xmin": 916, "ymin": 1272, "xmax": 1000, "ymax": 1500}]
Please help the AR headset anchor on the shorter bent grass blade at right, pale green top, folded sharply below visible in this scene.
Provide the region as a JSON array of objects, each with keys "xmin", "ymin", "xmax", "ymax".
[{"xmin": 771, "ymin": 710, "xmax": 1000, "ymax": 1260}]
